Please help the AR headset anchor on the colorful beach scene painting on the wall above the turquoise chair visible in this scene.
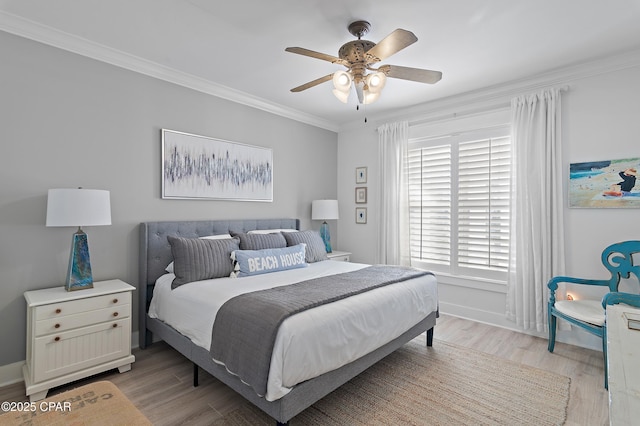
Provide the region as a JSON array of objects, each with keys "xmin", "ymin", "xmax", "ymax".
[{"xmin": 569, "ymin": 158, "xmax": 640, "ymax": 208}]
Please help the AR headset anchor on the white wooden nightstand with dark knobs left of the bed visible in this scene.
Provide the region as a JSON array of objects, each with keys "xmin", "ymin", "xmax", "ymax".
[{"xmin": 22, "ymin": 280, "xmax": 135, "ymax": 402}]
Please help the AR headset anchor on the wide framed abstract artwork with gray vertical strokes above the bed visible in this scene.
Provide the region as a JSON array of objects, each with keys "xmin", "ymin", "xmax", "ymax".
[{"xmin": 162, "ymin": 129, "xmax": 273, "ymax": 201}]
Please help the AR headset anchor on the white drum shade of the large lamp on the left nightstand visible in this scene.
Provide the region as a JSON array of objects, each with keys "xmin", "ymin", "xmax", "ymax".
[{"xmin": 47, "ymin": 188, "xmax": 111, "ymax": 226}]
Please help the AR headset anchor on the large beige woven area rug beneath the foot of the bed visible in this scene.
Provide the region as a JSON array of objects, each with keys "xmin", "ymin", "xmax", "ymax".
[{"xmin": 215, "ymin": 340, "xmax": 571, "ymax": 426}]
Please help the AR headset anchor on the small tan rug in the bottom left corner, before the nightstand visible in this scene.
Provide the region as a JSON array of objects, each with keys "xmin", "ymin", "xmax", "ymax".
[{"xmin": 0, "ymin": 381, "xmax": 151, "ymax": 426}]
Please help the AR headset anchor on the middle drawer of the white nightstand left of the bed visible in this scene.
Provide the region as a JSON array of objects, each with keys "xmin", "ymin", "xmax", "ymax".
[{"xmin": 36, "ymin": 304, "xmax": 131, "ymax": 337}]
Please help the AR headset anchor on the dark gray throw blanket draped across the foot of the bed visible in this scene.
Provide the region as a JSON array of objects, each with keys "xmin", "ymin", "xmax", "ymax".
[{"xmin": 210, "ymin": 265, "xmax": 430, "ymax": 396}]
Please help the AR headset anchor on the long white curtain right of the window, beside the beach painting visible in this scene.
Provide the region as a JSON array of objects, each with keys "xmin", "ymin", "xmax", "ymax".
[{"xmin": 507, "ymin": 89, "xmax": 565, "ymax": 332}]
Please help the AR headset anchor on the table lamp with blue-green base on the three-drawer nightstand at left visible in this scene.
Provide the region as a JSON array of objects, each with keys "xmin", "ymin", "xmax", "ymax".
[{"xmin": 46, "ymin": 188, "xmax": 111, "ymax": 291}]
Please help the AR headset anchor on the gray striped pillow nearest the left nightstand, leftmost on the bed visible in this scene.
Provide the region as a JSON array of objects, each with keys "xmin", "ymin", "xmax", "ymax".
[{"xmin": 167, "ymin": 236, "xmax": 240, "ymax": 289}]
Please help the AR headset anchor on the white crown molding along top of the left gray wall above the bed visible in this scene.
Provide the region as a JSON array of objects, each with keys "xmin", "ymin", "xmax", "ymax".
[{"xmin": 0, "ymin": 11, "xmax": 338, "ymax": 132}]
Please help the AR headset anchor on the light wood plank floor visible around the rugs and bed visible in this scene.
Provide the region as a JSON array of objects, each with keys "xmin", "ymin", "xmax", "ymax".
[{"xmin": 0, "ymin": 315, "xmax": 609, "ymax": 426}]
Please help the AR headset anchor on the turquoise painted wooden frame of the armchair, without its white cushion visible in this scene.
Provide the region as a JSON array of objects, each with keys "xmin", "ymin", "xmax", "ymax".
[{"xmin": 547, "ymin": 241, "xmax": 640, "ymax": 388}]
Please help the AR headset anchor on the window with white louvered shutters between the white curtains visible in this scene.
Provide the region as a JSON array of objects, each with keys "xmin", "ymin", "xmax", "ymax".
[{"xmin": 408, "ymin": 128, "xmax": 511, "ymax": 280}]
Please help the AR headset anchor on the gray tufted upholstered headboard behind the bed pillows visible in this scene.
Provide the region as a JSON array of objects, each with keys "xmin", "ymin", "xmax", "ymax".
[{"xmin": 138, "ymin": 219, "xmax": 300, "ymax": 347}]
